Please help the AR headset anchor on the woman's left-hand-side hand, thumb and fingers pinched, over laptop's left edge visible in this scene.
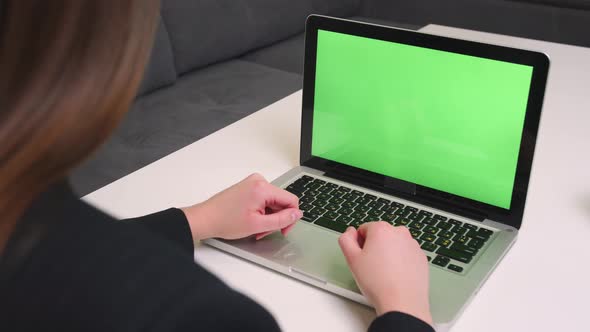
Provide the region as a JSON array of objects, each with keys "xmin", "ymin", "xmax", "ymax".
[{"xmin": 182, "ymin": 174, "xmax": 302, "ymax": 241}]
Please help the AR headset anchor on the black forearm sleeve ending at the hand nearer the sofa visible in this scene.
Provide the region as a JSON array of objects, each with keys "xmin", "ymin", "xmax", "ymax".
[{"xmin": 123, "ymin": 208, "xmax": 195, "ymax": 255}]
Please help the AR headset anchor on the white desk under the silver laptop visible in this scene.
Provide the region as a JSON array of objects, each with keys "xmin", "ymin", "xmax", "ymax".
[{"xmin": 85, "ymin": 26, "xmax": 590, "ymax": 332}]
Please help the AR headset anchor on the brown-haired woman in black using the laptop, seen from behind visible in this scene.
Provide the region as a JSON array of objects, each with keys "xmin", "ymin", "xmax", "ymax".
[{"xmin": 0, "ymin": 0, "xmax": 432, "ymax": 331}]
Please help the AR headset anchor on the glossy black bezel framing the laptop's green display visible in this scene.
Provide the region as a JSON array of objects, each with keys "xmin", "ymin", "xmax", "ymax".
[{"xmin": 300, "ymin": 15, "xmax": 549, "ymax": 229}]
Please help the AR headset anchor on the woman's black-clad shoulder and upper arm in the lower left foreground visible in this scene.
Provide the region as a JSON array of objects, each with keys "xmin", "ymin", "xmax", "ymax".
[{"xmin": 0, "ymin": 183, "xmax": 278, "ymax": 331}]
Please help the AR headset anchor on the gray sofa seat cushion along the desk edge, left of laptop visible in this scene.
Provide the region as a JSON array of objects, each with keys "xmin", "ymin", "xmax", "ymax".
[{"xmin": 71, "ymin": 60, "xmax": 301, "ymax": 196}]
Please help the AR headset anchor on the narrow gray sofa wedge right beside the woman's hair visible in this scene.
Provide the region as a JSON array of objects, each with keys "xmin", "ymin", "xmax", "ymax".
[{"xmin": 138, "ymin": 19, "xmax": 176, "ymax": 95}]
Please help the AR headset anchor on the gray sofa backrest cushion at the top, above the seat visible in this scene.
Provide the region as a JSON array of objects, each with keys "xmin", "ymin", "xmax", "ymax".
[{"xmin": 161, "ymin": 0, "xmax": 360, "ymax": 74}]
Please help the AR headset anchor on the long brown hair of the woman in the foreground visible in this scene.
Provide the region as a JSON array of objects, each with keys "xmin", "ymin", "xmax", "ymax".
[{"xmin": 0, "ymin": 0, "xmax": 158, "ymax": 252}]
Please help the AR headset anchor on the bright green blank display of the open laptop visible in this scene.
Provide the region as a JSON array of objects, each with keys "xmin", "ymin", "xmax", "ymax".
[{"xmin": 312, "ymin": 30, "xmax": 532, "ymax": 209}]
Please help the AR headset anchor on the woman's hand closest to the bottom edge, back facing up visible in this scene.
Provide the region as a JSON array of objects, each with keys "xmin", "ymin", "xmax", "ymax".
[{"xmin": 338, "ymin": 221, "xmax": 432, "ymax": 325}]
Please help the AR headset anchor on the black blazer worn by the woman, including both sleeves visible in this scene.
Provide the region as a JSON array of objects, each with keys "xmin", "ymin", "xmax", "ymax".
[{"xmin": 0, "ymin": 183, "xmax": 433, "ymax": 332}]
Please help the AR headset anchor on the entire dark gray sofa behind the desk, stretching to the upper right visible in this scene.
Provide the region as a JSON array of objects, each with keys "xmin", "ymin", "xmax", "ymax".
[{"xmin": 71, "ymin": 0, "xmax": 590, "ymax": 195}]
